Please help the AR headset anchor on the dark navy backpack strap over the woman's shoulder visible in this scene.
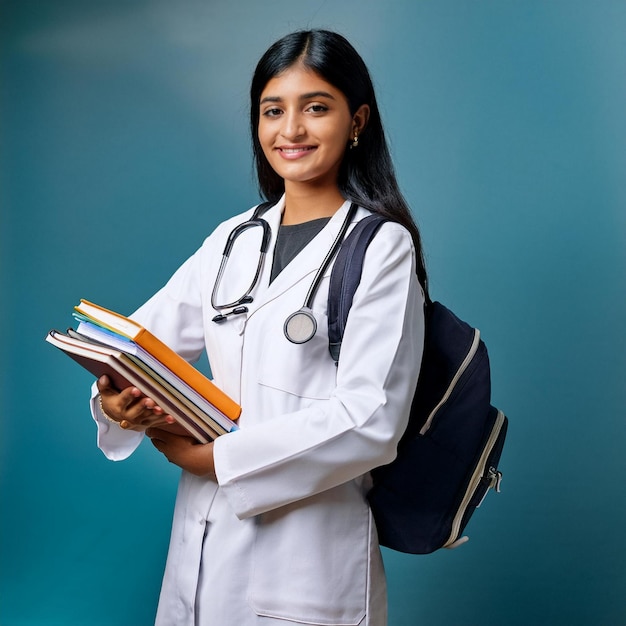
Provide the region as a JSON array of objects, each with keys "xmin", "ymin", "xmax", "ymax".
[{"xmin": 328, "ymin": 213, "xmax": 389, "ymax": 363}]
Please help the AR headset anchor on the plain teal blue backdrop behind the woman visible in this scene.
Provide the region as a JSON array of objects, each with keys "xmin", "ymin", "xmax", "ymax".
[{"xmin": 0, "ymin": 0, "xmax": 626, "ymax": 626}]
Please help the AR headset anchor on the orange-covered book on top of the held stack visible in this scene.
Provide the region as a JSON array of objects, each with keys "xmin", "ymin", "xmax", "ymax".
[{"xmin": 74, "ymin": 300, "xmax": 241, "ymax": 420}]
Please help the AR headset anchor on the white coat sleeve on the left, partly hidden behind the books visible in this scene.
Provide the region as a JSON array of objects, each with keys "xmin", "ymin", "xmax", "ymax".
[{"xmin": 91, "ymin": 240, "xmax": 211, "ymax": 461}]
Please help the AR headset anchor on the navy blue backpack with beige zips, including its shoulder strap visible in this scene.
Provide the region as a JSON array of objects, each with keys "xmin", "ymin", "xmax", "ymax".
[{"xmin": 328, "ymin": 215, "xmax": 508, "ymax": 554}]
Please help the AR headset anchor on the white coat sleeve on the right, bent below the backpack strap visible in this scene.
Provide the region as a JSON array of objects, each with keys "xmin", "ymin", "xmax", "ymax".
[{"xmin": 214, "ymin": 223, "xmax": 424, "ymax": 518}]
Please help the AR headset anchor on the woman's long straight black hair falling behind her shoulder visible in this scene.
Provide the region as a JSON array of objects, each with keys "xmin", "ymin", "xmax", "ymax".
[{"xmin": 250, "ymin": 30, "xmax": 427, "ymax": 291}]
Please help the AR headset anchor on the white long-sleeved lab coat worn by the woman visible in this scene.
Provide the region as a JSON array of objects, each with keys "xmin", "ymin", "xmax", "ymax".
[{"xmin": 92, "ymin": 201, "xmax": 423, "ymax": 626}]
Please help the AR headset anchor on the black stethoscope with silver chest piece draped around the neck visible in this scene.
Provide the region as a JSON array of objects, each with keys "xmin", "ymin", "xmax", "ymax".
[{"xmin": 211, "ymin": 203, "xmax": 357, "ymax": 343}]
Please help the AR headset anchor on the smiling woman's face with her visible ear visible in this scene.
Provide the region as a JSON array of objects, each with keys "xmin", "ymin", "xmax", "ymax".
[{"xmin": 258, "ymin": 64, "xmax": 369, "ymax": 189}]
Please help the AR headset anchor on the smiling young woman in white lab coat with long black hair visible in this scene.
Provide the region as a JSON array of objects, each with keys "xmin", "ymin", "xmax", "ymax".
[{"xmin": 92, "ymin": 30, "xmax": 426, "ymax": 626}]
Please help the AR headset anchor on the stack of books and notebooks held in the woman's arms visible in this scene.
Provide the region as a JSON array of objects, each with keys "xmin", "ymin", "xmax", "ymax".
[{"xmin": 46, "ymin": 300, "xmax": 241, "ymax": 443}]
